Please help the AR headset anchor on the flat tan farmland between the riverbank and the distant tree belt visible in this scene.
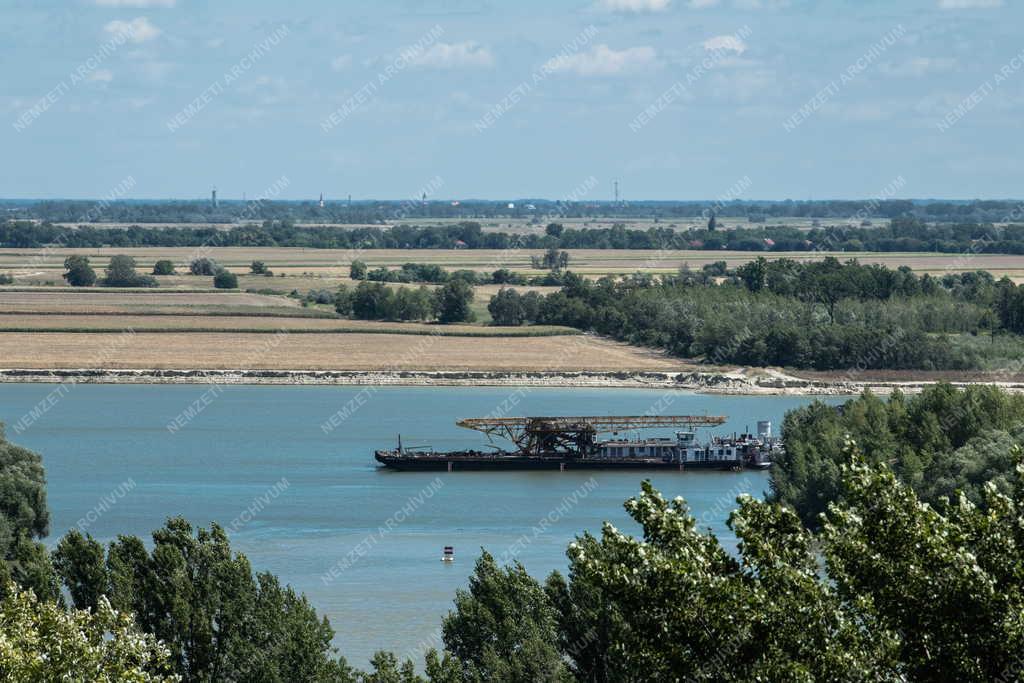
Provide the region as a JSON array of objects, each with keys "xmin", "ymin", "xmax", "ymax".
[{"xmin": 0, "ymin": 248, "xmax": 1024, "ymax": 372}]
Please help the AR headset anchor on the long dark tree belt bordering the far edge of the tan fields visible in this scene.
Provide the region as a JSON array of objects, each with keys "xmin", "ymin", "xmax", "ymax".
[{"xmin": 6, "ymin": 216, "xmax": 1024, "ymax": 254}]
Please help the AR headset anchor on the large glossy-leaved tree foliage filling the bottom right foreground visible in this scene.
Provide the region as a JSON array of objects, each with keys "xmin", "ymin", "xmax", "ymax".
[{"xmin": 536, "ymin": 446, "xmax": 1024, "ymax": 681}]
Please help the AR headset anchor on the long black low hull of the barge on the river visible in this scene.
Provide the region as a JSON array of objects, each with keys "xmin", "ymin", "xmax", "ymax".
[{"xmin": 374, "ymin": 451, "xmax": 745, "ymax": 472}]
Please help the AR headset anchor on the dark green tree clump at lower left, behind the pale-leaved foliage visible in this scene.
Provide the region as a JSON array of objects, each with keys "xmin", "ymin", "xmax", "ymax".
[{"xmin": 51, "ymin": 518, "xmax": 347, "ymax": 681}]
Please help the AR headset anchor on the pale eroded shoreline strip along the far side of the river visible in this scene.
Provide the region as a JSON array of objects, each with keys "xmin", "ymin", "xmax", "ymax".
[{"xmin": 0, "ymin": 368, "xmax": 1024, "ymax": 395}]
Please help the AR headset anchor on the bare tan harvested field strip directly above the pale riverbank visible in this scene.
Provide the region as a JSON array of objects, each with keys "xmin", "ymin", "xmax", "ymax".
[{"xmin": 0, "ymin": 332, "xmax": 683, "ymax": 372}]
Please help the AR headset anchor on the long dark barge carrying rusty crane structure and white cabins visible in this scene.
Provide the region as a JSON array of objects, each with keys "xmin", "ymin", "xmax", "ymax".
[{"xmin": 374, "ymin": 416, "xmax": 782, "ymax": 472}]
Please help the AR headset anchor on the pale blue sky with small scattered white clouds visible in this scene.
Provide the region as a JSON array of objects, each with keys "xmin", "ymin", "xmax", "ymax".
[{"xmin": 0, "ymin": 0, "xmax": 1024, "ymax": 201}]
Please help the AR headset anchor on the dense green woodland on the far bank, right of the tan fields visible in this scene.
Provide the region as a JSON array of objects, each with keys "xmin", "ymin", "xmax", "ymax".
[{"xmin": 488, "ymin": 257, "xmax": 1024, "ymax": 374}]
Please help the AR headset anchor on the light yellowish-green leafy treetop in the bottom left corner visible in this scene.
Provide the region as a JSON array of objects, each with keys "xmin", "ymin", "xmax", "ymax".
[{"xmin": 0, "ymin": 584, "xmax": 179, "ymax": 683}]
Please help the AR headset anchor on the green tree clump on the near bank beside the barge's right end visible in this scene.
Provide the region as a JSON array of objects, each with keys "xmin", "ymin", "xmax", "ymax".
[{"xmin": 770, "ymin": 384, "xmax": 1024, "ymax": 528}]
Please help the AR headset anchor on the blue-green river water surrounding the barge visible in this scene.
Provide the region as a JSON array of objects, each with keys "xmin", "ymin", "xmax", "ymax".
[{"xmin": 0, "ymin": 384, "xmax": 837, "ymax": 666}]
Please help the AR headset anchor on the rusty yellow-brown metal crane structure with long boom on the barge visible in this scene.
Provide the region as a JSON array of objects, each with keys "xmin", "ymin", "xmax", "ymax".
[{"xmin": 456, "ymin": 415, "xmax": 726, "ymax": 458}]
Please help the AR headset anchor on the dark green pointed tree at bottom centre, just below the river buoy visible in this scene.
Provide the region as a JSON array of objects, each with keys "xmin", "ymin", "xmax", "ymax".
[{"xmin": 441, "ymin": 551, "xmax": 570, "ymax": 683}]
